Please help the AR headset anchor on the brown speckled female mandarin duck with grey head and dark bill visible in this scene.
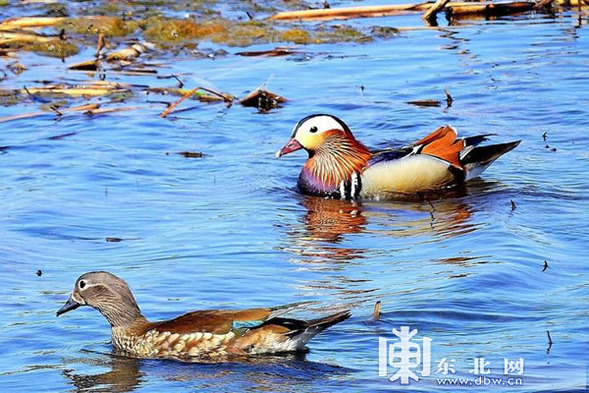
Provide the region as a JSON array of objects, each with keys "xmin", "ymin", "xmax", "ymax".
[{"xmin": 57, "ymin": 272, "xmax": 350, "ymax": 361}]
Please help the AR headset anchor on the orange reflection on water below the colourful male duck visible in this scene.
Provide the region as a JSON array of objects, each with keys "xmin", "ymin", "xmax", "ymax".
[{"xmin": 291, "ymin": 184, "xmax": 484, "ymax": 248}]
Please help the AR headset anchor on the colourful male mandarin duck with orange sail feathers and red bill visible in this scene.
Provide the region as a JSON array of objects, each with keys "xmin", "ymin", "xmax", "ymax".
[{"xmin": 276, "ymin": 114, "xmax": 521, "ymax": 199}]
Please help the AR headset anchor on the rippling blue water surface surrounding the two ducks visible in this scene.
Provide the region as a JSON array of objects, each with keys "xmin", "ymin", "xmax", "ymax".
[{"xmin": 0, "ymin": 3, "xmax": 589, "ymax": 392}]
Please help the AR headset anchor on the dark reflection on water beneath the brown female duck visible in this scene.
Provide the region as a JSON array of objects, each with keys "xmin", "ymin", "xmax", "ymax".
[{"xmin": 62, "ymin": 351, "xmax": 353, "ymax": 393}]
